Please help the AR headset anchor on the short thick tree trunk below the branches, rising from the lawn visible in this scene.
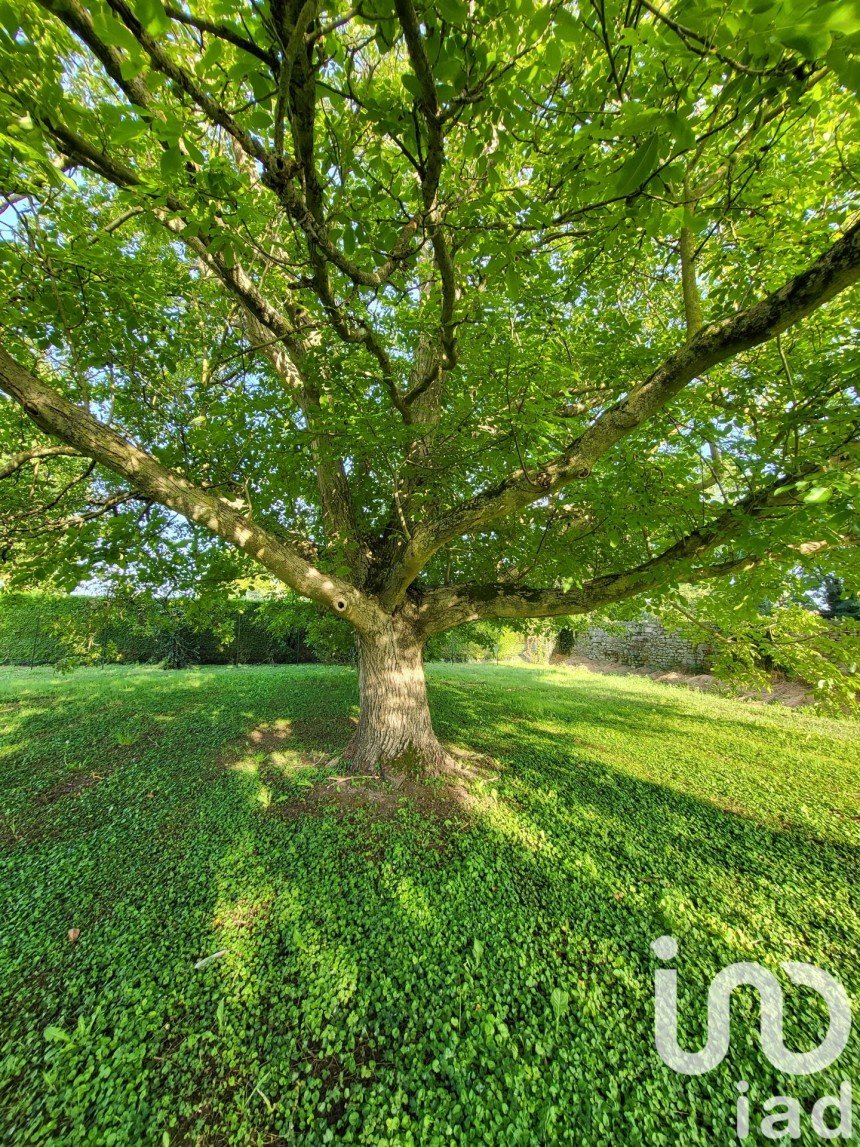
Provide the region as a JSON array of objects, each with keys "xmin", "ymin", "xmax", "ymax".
[{"xmin": 342, "ymin": 617, "xmax": 449, "ymax": 777}]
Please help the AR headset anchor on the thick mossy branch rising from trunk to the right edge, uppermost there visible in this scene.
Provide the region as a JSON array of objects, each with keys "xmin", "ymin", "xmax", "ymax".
[{"xmin": 386, "ymin": 223, "xmax": 860, "ymax": 600}]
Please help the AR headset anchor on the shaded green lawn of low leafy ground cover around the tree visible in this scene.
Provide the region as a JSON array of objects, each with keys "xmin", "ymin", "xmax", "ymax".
[{"xmin": 0, "ymin": 666, "xmax": 860, "ymax": 1147}]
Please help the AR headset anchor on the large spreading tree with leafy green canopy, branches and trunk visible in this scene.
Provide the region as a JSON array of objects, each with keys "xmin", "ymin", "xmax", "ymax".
[{"xmin": 0, "ymin": 0, "xmax": 860, "ymax": 770}]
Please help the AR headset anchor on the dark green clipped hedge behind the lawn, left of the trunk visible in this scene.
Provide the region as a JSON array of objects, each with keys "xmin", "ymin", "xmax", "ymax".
[{"xmin": 0, "ymin": 592, "xmax": 318, "ymax": 665}]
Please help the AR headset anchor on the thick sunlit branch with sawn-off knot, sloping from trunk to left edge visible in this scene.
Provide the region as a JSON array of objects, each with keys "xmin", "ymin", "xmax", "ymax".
[{"xmin": 0, "ymin": 348, "xmax": 378, "ymax": 629}]
